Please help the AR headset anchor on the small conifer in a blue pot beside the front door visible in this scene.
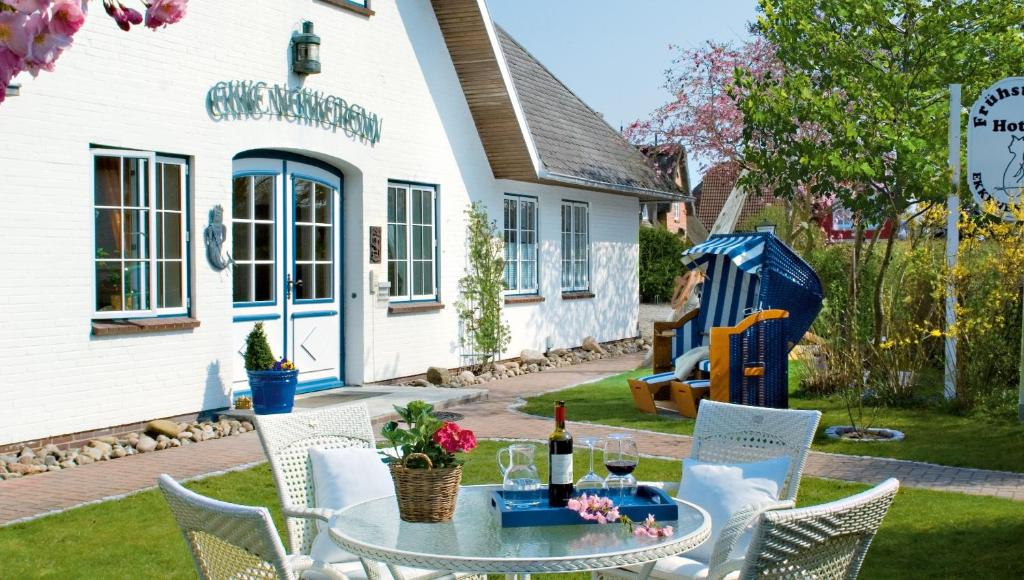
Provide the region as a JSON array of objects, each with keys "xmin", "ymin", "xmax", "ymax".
[{"xmin": 245, "ymin": 322, "xmax": 299, "ymax": 415}]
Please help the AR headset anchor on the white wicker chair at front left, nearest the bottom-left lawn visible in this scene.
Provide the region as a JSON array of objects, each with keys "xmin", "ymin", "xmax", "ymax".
[{"xmin": 159, "ymin": 473, "xmax": 364, "ymax": 580}]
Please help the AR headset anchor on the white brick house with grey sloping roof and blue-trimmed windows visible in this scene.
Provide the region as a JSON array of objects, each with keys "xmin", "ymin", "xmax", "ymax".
[{"xmin": 0, "ymin": 0, "xmax": 681, "ymax": 446}]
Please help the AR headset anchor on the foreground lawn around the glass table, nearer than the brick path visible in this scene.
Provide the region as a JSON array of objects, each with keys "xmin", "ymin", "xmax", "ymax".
[{"xmin": 0, "ymin": 442, "xmax": 1024, "ymax": 580}]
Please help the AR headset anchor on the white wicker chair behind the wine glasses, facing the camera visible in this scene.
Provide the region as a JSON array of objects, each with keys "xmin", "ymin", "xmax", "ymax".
[{"xmin": 595, "ymin": 400, "xmax": 821, "ymax": 580}]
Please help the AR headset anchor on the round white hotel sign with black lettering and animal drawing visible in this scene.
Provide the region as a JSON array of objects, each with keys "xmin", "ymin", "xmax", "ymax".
[{"xmin": 967, "ymin": 77, "xmax": 1024, "ymax": 221}]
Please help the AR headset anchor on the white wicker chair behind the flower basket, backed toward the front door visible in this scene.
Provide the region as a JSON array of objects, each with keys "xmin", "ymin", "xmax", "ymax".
[{"xmin": 256, "ymin": 403, "xmax": 479, "ymax": 580}]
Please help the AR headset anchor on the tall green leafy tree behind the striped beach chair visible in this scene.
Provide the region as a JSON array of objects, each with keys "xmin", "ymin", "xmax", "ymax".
[{"xmin": 736, "ymin": 0, "xmax": 1024, "ymax": 342}]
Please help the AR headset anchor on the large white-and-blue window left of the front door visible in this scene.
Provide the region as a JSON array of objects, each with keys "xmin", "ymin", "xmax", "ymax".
[{"xmin": 92, "ymin": 149, "xmax": 190, "ymax": 319}]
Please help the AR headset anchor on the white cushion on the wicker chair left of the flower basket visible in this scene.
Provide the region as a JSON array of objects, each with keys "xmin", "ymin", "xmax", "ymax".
[{"xmin": 309, "ymin": 447, "xmax": 394, "ymax": 563}]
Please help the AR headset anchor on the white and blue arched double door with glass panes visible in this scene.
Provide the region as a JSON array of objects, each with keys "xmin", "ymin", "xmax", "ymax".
[{"xmin": 230, "ymin": 157, "xmax": 344, "ymax": 393}]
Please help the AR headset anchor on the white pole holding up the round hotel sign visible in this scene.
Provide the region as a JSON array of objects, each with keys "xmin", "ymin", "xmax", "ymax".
[{"xmin": 943, "ymin": 85, "xmax": 958, "ymax": 399}]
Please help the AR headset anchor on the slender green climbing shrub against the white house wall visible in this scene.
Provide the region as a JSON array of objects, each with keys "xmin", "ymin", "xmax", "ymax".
[{"xmin": 456, "ymin": 202, "xmax": 511, "ymax": 365}]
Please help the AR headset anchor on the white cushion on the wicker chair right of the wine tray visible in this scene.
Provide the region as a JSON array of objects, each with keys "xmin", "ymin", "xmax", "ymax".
[{"xmin": 677, "ymin": 456, "xmax": 790, "ymax": 563}]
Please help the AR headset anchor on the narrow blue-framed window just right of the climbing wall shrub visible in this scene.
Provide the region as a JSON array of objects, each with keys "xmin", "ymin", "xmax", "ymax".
[{"xmin": 503, "ymin": 194, "xmax": 538, "ymax": 294}]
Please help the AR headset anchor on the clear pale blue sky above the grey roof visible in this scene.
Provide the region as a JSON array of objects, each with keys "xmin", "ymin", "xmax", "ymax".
[{"xmin": 487, "ymin": 0, "xmax": 757, "ymax": 184}]
